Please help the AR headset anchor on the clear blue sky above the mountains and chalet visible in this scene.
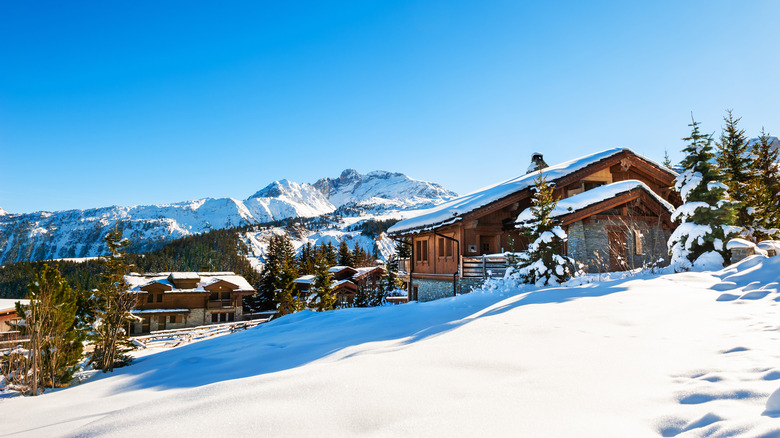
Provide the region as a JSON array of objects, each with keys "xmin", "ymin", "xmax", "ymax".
[{"xmin": 0, "ymin": 0, "xmax": 780, "ymax": 213}]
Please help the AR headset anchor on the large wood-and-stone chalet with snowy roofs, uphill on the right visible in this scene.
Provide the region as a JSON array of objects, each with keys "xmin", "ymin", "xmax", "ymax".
[{"xmin": 388, "ymin": 148, "xmax": 681, "ymax": 301}]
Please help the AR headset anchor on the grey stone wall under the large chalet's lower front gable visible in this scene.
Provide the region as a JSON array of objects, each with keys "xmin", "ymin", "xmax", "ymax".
[{"xmin": 567, "ymin": 219, "xmax": 671, "ymax": 272}]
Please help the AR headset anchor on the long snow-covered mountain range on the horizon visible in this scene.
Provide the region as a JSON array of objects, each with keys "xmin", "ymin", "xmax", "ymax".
[{"xmin": 0, "ymin": 169, "xmax": 456, "ymax": 265}]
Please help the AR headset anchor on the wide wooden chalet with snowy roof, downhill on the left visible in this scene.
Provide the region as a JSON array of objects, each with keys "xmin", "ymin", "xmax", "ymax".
[{"xmin": 125, "ymin": 272, "xmax": 255, "ymax": 334}]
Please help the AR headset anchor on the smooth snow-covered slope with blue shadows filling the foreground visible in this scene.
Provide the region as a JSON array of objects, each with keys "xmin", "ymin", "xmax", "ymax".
[{"xmin": 0, "ymin": 256, "xmax": 780, "ymax": 438}]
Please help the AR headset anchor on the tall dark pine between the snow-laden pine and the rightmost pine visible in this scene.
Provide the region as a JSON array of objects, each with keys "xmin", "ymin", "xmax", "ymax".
[{"xmin": 716, "ymin": 110, "xmax": 751, "ymax": 227}]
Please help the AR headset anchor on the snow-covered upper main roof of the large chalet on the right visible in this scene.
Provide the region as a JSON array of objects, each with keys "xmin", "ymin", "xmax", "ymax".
[{"xmin": 387, "ymin": 148, "xmax": 673, "ymax": 235}]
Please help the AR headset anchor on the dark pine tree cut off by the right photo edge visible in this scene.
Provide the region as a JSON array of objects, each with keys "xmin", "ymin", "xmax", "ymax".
[{"xmin": 746, "ymin": 128, "xmax": 780, "ymax": 240}]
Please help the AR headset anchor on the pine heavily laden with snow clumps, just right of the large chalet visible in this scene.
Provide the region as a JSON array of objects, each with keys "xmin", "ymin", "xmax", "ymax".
[{"xmin": 667, "ymin": 117, "xmax": 742, "ymax": 271}]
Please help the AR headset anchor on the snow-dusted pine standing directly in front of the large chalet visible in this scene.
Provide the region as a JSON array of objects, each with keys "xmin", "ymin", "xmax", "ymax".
[{"xmin": 516, "ymin": 171, "xmax": 575, "ymax": 286}]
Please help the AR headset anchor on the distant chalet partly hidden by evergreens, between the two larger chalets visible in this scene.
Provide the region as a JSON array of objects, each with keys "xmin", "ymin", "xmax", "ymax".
[{"xmin": 293, "ymin": 266, "xmax": 385, "ymax": 307}]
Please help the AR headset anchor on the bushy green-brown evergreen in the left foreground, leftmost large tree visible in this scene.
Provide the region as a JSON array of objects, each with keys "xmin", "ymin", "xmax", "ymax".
[{"xmin": 9, "ymin": 265, "xmax": 86, "ymax": 395}]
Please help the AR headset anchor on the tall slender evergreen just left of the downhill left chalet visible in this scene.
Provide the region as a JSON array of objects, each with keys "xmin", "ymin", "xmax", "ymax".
[{"xmin": 92, "ymin": 224, "xmax": 138, "ymax": 372}]
